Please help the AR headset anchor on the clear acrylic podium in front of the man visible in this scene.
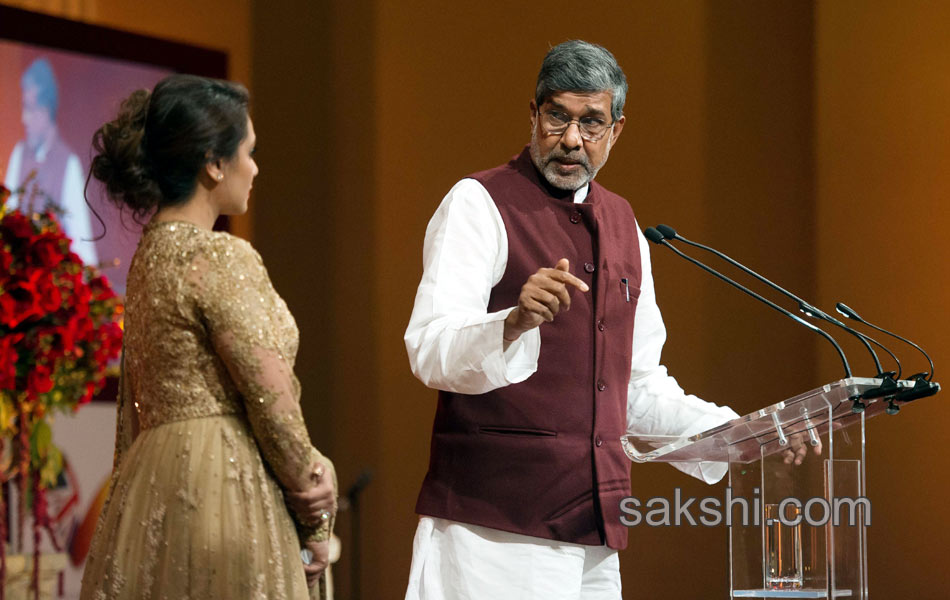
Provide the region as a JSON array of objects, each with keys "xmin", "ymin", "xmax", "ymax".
[{"xmin": 621, "ymin": 377, "xmax": 928, "ymax": 600}]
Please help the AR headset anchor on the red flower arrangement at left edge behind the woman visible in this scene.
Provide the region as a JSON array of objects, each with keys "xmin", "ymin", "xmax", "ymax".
[{"xmin": 0, "ymin": 185, "xmax": 123, "ymax": 598}]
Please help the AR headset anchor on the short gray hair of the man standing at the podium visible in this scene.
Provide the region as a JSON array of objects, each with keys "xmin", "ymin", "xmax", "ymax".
[{"xmin": 534, "ymin": 40, "xmax": 627, "ymax": 121}]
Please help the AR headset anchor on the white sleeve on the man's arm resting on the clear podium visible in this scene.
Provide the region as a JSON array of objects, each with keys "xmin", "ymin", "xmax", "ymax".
[{"xmin": 627, "ymin": 227, "xmax": 739, "ymax": 483}]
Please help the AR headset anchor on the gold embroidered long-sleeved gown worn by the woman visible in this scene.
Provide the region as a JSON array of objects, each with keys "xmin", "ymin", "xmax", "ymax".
[{"xmin": 81, "ymin": 222, "xmax": 334, "ymax": 600}]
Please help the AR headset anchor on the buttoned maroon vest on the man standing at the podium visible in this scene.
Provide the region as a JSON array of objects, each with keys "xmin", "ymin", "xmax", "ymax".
[{"xmin": 416, "ymin": 148, "xmax": 641, "ymax": 549}]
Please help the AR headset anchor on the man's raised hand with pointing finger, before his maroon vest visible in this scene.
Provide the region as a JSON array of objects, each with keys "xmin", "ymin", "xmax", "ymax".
[{"xmin": 503, "ymin": 258, "xmax": 590, "ymax": 346}]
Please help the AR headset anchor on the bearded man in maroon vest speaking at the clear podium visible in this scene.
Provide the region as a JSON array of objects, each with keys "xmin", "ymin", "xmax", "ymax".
[{"xmin": 405, "ymin": 41, "xmax": 737, "ymax": 600}]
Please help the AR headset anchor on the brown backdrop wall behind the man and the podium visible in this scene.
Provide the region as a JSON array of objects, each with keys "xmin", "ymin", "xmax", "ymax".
[{"xmin": 254, "ymin": 1, "xmax": 950, "ymax": 599}]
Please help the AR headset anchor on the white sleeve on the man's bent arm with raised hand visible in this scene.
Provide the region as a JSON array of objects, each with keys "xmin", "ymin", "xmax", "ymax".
[{"xmin": 404, "ymin": 179, "xmax": 541, "ymax": 394}]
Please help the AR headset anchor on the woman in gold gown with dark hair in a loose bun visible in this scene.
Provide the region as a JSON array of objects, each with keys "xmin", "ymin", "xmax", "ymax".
[{"xmin": 81, "ymin": 75, "xmax": 336, "ymax": 600}]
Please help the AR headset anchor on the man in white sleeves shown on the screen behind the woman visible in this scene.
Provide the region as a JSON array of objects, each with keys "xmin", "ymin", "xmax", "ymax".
[{"xmin": 3, "ymin": 58, "xmax": 99, "ymax": 265}]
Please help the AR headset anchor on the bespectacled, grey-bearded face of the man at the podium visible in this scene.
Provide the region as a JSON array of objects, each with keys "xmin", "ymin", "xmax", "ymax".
[{"xmin": 530, "ymin": 91, "xmax": 625, "ymax": 191}]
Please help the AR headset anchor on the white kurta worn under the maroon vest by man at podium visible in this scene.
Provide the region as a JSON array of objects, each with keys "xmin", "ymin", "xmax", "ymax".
[{"xmin": 405, "ymin": 179, "xmax": 738, "ymax": 600}]
